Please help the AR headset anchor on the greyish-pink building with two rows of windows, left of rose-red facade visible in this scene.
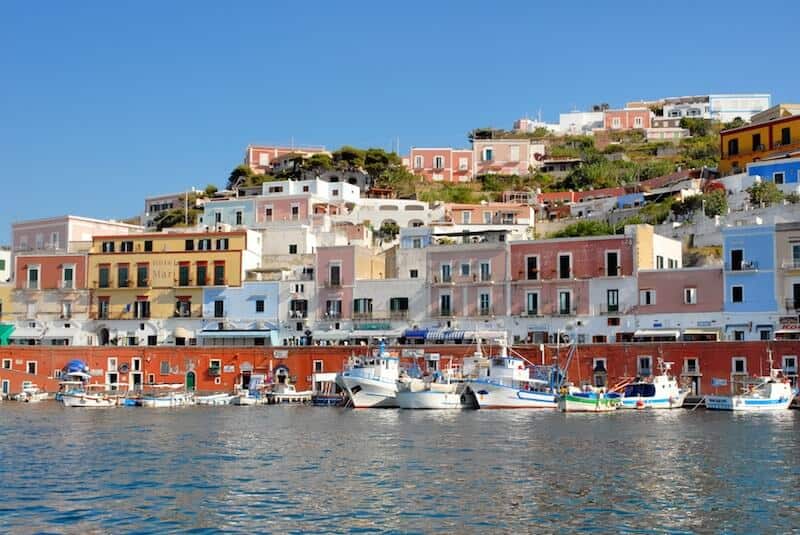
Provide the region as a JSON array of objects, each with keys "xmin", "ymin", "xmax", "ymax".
[{"xmin": 428, "ymin": 243, "xmax": 508, "ymax": 318}]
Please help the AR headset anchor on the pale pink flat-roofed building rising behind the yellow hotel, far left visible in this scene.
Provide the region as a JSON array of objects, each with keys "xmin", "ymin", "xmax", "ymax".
[{"xmin": 11, "ymin": 215, "xmax": 144, "ymax": 252}]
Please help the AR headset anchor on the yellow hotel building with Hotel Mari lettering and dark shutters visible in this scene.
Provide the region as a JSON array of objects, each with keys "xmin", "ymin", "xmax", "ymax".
[{"xmin": 88, "ymin": 231, "xmax": 260, "ymax": 320}]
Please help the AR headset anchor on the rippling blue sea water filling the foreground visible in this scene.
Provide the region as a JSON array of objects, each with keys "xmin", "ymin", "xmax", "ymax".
[{"xmin": 0, "ymin": 402, "xmax": 800, "ymax": 533}]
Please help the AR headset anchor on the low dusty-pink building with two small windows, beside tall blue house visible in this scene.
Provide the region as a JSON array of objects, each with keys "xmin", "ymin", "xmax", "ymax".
[{"xmin": 636, "ymin": 268, "xmax": 724, "ymax": 314}]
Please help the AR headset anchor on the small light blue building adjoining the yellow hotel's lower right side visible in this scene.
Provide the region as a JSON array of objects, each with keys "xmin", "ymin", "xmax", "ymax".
[{"xmin": 198, "ymin": 281, "xmax": 279, "ymax": 345}]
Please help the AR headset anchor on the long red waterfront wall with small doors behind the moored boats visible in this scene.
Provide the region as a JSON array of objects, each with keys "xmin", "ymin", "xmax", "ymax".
[{"xmin": 0, "ymin": 341, "xmax": 800, "ymax": 394}]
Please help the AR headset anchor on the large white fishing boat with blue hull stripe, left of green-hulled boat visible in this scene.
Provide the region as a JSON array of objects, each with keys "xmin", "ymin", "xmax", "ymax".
[{"xmin": 464, "ymin": 340, "xmax": 556, "ymax": 409}]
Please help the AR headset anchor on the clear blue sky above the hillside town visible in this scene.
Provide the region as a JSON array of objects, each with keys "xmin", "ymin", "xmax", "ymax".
[{"xmin": 0, "ymin": 0, "xmax": 800, "ymax": 243}]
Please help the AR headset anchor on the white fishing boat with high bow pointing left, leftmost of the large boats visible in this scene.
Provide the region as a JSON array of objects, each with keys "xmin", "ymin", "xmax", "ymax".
[{"xmin": 336, "ymin": 342, "xmax": 400, "ymax": 408}]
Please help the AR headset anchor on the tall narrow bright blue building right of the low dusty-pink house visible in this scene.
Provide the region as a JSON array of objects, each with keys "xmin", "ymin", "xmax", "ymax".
[{"xmin": 722, "ymin": 225, "xmax": 778, "ymax": 312}]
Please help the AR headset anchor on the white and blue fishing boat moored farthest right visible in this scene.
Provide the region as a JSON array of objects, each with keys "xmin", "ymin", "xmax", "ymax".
[{"xmin": 705, "ymin": 355, "xmax": 797, "ymax": 412}]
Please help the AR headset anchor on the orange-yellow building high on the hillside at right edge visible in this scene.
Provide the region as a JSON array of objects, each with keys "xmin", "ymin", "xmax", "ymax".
[{"xmin": 719, "ymin": 115, "xmax": 800, "ymax": 175}]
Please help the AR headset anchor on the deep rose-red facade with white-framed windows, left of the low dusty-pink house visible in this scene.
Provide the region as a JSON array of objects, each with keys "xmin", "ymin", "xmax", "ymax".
[{"xmin": 510, "ymin": 236, "xmax": 634, "ymax": 316}]
